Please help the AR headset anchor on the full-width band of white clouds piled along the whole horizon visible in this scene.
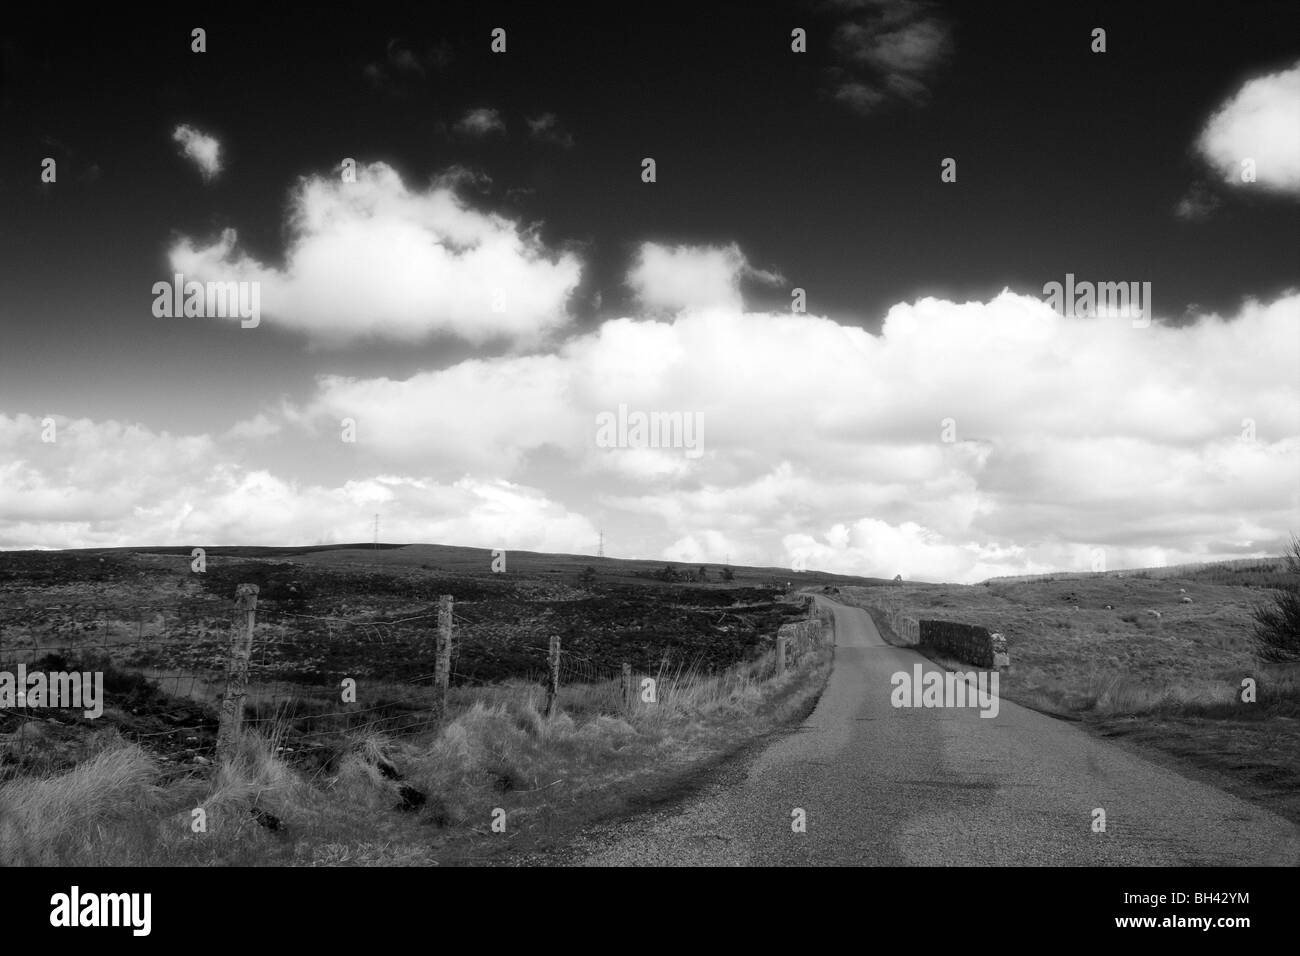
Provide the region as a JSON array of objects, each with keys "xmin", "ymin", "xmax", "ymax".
[{"xmin": 0, "ymin": 247, "xmax": 1300, "ymax": 581}]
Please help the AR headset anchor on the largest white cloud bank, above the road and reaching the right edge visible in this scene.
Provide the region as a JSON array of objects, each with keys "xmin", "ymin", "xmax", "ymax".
[{"xmin": 276, "ymin": 282, "xmax": 1300, "ymax": 580}]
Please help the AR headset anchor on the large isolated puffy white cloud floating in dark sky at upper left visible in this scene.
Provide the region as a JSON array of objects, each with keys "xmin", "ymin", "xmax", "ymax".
[{"xmin": 170, "ymin": 163, "xmax": 581, "ymax": 345}]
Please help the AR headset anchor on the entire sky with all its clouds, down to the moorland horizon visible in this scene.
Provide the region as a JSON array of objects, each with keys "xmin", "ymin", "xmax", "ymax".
[{"xmin": 0, "ymin": 0, "xmax": 1300, "ymax": 580}]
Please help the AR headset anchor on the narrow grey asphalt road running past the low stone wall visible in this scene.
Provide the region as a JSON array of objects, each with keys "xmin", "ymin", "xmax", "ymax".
[{"xmin": 571, "ymin": 597, "xmax": 1300, "ymax": 866}]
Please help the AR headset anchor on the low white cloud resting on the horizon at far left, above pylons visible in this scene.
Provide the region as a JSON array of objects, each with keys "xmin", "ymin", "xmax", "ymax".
[{"xmin": 0, "ymin": 414, "xmax": 598, "ymax": 551}]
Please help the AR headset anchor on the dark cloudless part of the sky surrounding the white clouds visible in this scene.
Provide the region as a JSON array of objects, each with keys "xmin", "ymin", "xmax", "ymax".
[{"xmin": 0, "ymin": 0, "xmax": 1300, "ymax": 427}]
